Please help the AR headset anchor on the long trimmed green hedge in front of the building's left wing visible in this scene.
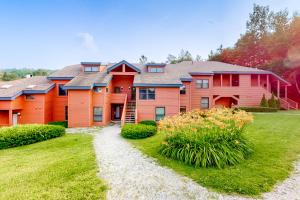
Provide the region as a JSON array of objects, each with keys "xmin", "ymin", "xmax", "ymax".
[{"xmin": 0, "ymin": 124, "xmax": 65, "ymax": 149}]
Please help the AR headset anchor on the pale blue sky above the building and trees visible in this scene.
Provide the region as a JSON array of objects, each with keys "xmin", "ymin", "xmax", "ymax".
[{"xmin": 0, "ymin": 0, "xmax": 300, "ymax": 69}]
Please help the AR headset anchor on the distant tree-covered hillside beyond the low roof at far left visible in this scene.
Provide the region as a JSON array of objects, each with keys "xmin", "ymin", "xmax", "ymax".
[{"xmin": 0, "ymin": 68, "xmax": 54, "ymax": 81}]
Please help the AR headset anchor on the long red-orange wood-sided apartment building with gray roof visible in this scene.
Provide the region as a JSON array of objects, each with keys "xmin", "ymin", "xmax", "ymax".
[{"xmin": 0, "ymin": 60, "xmax": 298, "ymax": 127}]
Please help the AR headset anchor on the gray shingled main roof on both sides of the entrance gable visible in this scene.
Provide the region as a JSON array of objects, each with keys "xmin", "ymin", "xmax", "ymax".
[{"xmin": 45, "ymin": 61, "xmax": 286, "ymax": 89}]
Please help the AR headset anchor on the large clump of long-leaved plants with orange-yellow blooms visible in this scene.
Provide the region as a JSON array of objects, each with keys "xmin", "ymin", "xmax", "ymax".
[{"xmin": 158, "ymin": 108, "xmax": 253, "ymax": 168}]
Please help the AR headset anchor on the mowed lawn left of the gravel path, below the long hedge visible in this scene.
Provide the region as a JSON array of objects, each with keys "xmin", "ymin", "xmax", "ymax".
[{"xmin": 0, "ymin": 134, "xmax": 106, "ymax": 199}]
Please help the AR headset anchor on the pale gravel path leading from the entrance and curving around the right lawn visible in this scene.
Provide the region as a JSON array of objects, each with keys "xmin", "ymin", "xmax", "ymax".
[{"xmin": 94, "ymin": 125, "xmax": 300, "ymax": 200}]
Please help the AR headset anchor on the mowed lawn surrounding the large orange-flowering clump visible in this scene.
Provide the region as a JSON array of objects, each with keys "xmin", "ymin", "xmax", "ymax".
[{"xmin": 129, "ymin": 112, "xmax": 300, "ymax": 196}]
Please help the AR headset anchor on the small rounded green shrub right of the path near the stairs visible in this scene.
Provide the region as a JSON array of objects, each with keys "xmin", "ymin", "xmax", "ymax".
[{"xmin": 121, "ymin": 124, "xmax": 157, "ymax": 139}]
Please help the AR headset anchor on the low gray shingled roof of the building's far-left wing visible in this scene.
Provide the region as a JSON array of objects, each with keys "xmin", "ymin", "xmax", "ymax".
[{"xmin": 0, "ymin": 76, "xmax": 55, "ymax": 100}]
